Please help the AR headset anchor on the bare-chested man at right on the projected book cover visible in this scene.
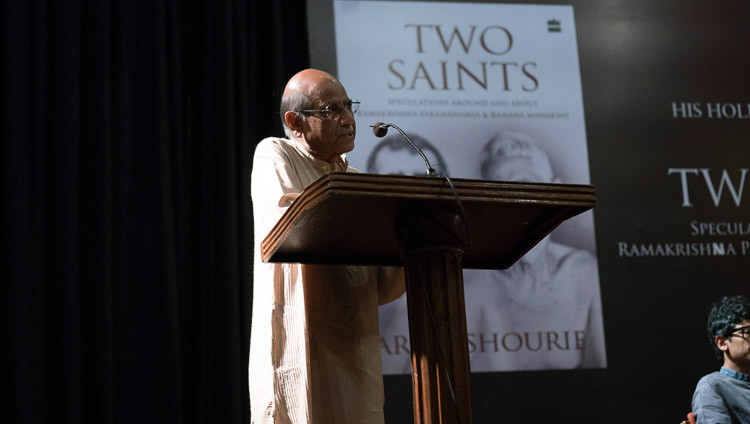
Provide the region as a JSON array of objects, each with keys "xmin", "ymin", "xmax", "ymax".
[{"xmin": 464, "ymin": 131, "xmax": 606, "ymax": 371}]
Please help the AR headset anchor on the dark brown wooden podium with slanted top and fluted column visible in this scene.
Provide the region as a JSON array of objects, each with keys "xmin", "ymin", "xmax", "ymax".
[{"xmin": 261, "ymin": 172, "xmax": 596, "ymax": 424}]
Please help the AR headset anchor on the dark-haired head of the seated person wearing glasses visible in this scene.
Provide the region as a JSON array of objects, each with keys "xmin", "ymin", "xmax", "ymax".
[{"xmin": 708, "ymin": 295, "xmax": 750, "ymax": 366}]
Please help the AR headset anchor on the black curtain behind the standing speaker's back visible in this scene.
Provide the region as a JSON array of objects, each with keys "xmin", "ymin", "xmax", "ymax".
[{"xmin": 0, "ymin": 0, "xmax": 309, "ymax": 423}]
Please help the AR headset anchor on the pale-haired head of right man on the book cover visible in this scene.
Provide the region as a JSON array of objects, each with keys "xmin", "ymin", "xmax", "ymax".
[{"xmin": 479, "ymin": 131, "xmax": 554, "ymax": 183}]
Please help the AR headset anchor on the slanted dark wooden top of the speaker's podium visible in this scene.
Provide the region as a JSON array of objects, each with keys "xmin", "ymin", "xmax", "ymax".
[{"xmin": 261, "ymin": 172, "xmax": 596, "ymax": 269}]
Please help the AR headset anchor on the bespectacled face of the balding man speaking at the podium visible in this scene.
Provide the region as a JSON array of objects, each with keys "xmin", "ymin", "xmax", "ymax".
[{"xmin": 300, "ymin": 79, "xmax": 357, "ymax": 162}]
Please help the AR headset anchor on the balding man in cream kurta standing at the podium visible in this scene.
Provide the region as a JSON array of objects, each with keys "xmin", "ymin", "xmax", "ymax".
[{"xmin": 248, "ymin": 69, "xmax": 404, "ymax": 424}]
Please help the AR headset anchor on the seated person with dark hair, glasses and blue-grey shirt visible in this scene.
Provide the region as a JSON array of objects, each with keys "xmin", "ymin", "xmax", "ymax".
[{"xmin": 693, "ymin": 295, "xmax": 750, "ymax": 424}]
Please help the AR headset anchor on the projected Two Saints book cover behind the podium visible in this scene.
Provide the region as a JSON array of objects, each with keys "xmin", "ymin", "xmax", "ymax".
[{"xmin": 334, "ymin": 1, "xmax": 606, "ymax": 374}]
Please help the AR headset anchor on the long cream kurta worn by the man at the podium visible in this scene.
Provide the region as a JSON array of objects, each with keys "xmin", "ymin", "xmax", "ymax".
[{"xmin": 249, "ymin": 138, "xmax": 396, "ymax": 424}]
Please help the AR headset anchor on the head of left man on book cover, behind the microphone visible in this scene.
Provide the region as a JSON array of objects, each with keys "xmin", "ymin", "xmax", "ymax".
[{"xmin": 367, "ymin": 134, "xmax": 448, "ymax": 176}]
